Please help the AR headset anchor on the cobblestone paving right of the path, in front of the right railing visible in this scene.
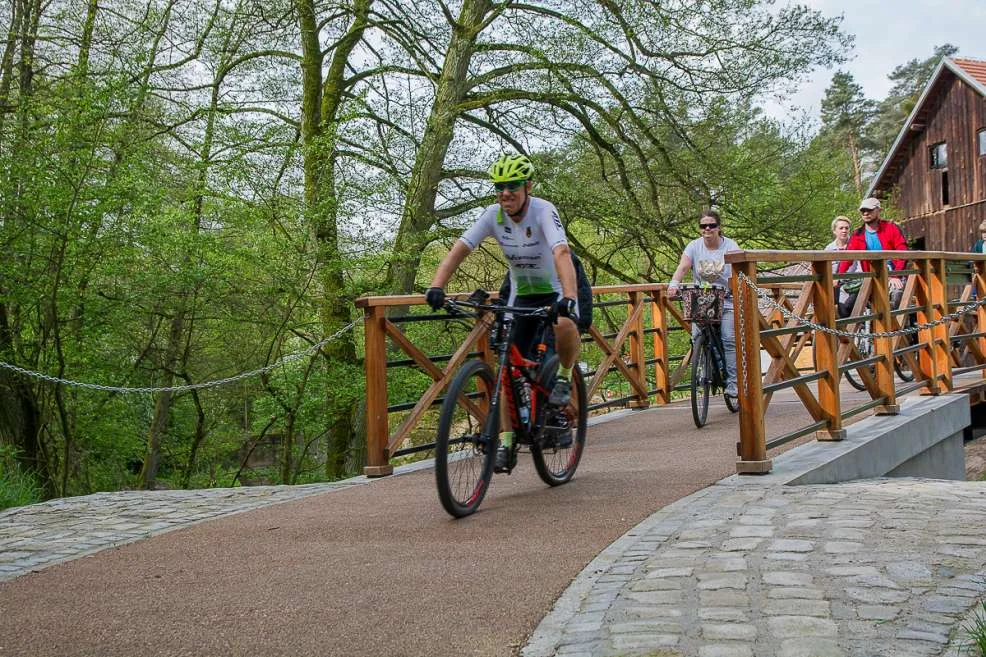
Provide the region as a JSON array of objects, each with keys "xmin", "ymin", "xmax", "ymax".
[{"xmin": 521, "ymin": 478, "xmax": 986, "ymax": 657}]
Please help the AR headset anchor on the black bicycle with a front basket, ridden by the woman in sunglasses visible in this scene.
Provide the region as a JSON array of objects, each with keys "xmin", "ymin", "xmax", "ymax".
[{"xmin": 680, "ymin": 285, "xmax": 739, "ymax": 429}]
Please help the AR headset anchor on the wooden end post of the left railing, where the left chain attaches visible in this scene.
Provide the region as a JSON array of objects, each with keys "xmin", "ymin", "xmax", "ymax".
[{"xmin": 356, "ymin": 299, "xmax": 394, "ymax": 477}]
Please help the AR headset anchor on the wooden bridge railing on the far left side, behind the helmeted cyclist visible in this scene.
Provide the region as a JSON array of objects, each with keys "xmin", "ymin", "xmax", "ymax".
[{"xmin": 356, "ymin": 284, "xmax": 792, "ymax": 476}]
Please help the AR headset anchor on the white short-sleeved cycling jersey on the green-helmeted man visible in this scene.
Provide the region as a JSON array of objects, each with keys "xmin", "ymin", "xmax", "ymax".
[{"xmin": 459, "ymin": 196, "xmax": 568, "ymax": 304}]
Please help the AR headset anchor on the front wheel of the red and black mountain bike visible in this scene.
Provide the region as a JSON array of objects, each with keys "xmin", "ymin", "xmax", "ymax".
[{"xmin": 435, "ymin": 360, "xmax": 497, "ymax": 518}]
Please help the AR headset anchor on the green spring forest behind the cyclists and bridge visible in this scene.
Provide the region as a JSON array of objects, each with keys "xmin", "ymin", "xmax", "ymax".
[{"xmin": 0, "ymin": 0, "xmax": 955, "ymax": 508}]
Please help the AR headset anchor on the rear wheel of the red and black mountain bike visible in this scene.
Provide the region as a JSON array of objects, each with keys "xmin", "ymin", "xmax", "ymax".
[{"xmin": 531, "ymin": 356, "xmax": 589, "ymax": 486}]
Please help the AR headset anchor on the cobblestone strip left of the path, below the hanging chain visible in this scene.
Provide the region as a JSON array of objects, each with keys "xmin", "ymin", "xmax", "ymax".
[{"xmin": 0, "ymin": 477, "xmax": 368, "ymax": 582}]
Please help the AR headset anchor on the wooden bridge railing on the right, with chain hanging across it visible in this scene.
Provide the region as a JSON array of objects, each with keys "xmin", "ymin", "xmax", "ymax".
[{"xmin": 726, "ymin": 251, "xmax": 986, "ymax": 473}]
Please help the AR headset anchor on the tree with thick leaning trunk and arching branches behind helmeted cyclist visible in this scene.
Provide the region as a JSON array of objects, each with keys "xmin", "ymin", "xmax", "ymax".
[{"xmin": 372, "ymin": 0, "xmax": 847, "ymax": 293}]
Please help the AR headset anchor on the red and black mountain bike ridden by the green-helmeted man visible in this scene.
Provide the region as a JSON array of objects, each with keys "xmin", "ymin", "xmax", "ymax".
[{"xmin": 435, "ymin": 290, "xmax": 588, "ymax": 518}]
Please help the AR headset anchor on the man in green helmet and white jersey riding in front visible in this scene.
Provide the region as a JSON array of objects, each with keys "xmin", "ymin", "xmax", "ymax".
[{"xmin": 425, "ymin": 155, "xmax": 581, "ymax": 471}]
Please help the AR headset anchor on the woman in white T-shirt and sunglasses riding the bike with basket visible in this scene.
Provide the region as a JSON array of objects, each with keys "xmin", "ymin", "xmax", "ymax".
[{"xmin": 668, "ymin": 210, "xmax": 740, "ymax": 398}]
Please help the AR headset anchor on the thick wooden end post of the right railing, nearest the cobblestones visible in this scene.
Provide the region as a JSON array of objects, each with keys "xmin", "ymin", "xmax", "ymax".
[{"xmin": 730, "ymin": 262, "xmax": 773, "ymax": 474}]
